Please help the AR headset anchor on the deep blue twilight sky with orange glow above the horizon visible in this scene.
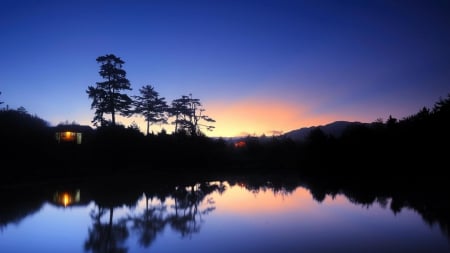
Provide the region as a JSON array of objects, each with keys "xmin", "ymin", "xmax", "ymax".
[{"xmin": 0, "ymin": 0, "xmax": 450, "ymax": 137}]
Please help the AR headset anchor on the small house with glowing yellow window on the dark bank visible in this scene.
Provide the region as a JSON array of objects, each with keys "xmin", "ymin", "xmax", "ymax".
[{"xmin": 53, "ymin": 124, "xmax": 94, "ymax": 144}]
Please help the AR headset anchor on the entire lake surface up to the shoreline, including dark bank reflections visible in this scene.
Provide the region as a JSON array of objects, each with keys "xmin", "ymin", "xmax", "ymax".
[{"xmin": 0, "ymin": 175, "xmax": 450, "ymax": 253}]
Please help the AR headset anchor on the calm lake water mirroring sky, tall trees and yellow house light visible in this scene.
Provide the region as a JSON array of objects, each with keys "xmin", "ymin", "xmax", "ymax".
[{"xmin": 0, "ymin": 180, "xmax": 450, "ymax": 253}]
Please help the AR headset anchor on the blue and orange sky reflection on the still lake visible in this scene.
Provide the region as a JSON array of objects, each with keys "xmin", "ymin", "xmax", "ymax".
[{"xmin": 0, "ymin": 183, "xmax": 450, "ymax": 253}]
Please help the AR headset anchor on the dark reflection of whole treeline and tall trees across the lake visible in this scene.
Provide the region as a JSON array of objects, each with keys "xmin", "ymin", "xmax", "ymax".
[{"xmin": 0, "ymin": 174, "xmax": 450, "ymax": 253}]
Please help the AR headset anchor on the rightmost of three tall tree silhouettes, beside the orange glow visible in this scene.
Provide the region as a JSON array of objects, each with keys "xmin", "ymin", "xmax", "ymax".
[{"xmin": 170, "ymin": 94, "xmax": 216, "ymax": 136}]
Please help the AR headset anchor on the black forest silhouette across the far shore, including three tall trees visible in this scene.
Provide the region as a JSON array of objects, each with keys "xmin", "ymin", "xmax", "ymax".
[{"xmin": 0, "ymin": 54, "xmax": 450, "ymax": 185}]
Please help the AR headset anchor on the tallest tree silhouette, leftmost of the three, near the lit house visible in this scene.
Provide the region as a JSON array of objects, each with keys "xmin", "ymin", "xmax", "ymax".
[{"xmin": 86, "ymin": 54, "xmax": 133, "ymax": 126}]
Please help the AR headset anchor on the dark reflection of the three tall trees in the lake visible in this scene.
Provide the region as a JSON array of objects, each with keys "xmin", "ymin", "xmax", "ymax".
[{"xmin": 84, "ymin": 182, "xmax": 225, "ymax": 253}]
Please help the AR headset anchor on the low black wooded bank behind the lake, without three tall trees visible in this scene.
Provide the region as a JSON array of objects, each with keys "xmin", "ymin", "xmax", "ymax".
[{"xmin": 0, "ymin": 89, "xmax": 450, "ymax": 183}]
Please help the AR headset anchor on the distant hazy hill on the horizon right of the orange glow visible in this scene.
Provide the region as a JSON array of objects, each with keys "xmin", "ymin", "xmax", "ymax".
[{"xmin": 283, "ymin": 121, "xmax": 366, "ymax": 141}]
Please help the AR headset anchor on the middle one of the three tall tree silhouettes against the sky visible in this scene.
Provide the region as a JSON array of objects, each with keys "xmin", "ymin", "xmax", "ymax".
[{"xmin": 134, "ymin": 85, "xmax": 168, "ymax": 135}]
